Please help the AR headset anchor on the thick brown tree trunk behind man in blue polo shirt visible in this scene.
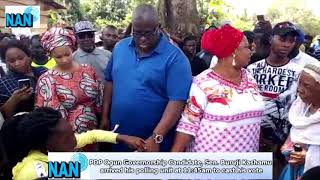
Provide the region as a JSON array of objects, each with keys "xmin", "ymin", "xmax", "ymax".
[{"xmin": 157, "ymin": 0, "xmax": 200, "ymax": 36}]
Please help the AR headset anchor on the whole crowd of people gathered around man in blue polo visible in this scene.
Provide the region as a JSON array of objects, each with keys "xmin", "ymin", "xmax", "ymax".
[{"xmin": 0, "ymin": 5, "xmax": 320, "ymax": 180}]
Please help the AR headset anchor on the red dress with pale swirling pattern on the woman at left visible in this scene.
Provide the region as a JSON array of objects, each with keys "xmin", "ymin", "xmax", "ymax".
[{"xmin": 36, "ymin": 65, "xmax": 103, "ymax": 133}]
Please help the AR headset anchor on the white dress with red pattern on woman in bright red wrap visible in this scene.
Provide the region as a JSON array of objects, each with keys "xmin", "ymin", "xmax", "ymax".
[{"xmin": 177, "ymin": 69, "xmax": 264, "ymax": 152}]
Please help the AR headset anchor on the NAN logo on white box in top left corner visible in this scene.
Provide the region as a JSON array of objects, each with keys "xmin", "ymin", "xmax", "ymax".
[{"xmin": 5, "ymin": 6, "xmax": 40, "ymax": 28}]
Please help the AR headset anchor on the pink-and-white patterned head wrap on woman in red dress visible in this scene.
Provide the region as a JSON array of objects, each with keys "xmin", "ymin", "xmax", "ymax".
[{"xmin": 41, "ymin": 27, "xmax": 76, "ymax": 52}]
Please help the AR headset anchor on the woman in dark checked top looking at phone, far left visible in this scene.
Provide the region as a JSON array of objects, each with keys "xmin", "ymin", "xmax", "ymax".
[{"xmin": 0, "ymin": 39, "xmax": 47, "ymax": 119}]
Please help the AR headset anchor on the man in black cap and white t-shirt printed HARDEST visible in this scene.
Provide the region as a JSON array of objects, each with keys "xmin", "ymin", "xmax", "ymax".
[{"xmin": 247, "ymin": 22, "xmax": 303, "ymax": 179}]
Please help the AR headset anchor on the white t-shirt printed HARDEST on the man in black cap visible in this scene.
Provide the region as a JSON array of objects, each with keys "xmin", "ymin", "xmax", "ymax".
[{"xmin": 247, "ymin": 59, "xmax": 302, "ymax": 143}]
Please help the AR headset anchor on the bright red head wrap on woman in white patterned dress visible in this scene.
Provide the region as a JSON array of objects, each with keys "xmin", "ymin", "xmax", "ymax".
[{"xmin": 201, "ymin": 25, "xmax": 244, "ymax": 59}]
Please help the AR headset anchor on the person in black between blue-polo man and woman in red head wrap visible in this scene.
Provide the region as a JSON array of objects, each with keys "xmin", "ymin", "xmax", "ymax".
[{"xmin": 182, "ymin": 36, "xmax": 209, "ymax": 76}]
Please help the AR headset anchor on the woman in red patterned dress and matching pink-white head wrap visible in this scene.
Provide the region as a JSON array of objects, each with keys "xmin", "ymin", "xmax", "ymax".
[{"xmin": 36, "ymin": 28, "xmax": 103, "ymax": 150}]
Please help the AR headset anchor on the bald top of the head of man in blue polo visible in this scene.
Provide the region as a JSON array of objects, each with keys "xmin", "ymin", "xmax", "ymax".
[{"xmin": 132, "ymin": 4, "xmax": 159, "ymax": 25}]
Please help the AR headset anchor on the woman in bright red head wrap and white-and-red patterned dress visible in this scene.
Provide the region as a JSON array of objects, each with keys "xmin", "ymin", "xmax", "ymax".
[{"xmin": 172, "ymin": 25, "xmax": 264, "ymax": 152}]
